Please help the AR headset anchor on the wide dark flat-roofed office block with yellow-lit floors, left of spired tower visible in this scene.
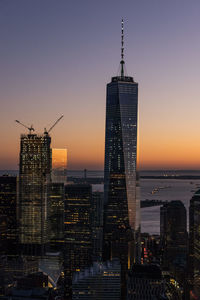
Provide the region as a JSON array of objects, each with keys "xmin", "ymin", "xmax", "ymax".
[{"xmin": 64, "ymin": 184, "xmax": 93, "ymax": 299}]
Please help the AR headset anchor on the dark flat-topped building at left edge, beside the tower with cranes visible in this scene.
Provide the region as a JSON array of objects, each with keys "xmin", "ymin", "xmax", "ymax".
[{"xmin": 0, "ymin": 175, "xmax": 18, "ymax": 255}]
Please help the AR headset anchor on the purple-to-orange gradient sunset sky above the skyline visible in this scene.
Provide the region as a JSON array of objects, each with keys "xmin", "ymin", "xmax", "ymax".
[{"xmin": 0, "ymin": 0, "xmax": 200, "ymax": 169}]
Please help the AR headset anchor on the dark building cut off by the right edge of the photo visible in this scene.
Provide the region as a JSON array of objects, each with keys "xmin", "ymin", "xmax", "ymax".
[{"xmin": 189, "ymin": 190, "xmax": 200, "ymax": 299}]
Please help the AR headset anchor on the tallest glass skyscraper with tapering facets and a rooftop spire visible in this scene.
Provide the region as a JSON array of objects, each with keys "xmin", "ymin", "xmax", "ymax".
[{"xmin": 104, "ymin": 20, "xmax": 140, "ymax": 296}]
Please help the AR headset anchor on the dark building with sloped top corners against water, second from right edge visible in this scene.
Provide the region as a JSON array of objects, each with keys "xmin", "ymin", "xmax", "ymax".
[{"xmin": 160, "ymin": 201, "xmax": 188, "ymax": 299}]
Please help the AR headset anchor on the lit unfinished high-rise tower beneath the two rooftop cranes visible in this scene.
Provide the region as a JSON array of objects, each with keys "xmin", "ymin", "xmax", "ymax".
[{"xmin": 19, "ymin": 134, "xmax": 51, "ymax": 255}]
